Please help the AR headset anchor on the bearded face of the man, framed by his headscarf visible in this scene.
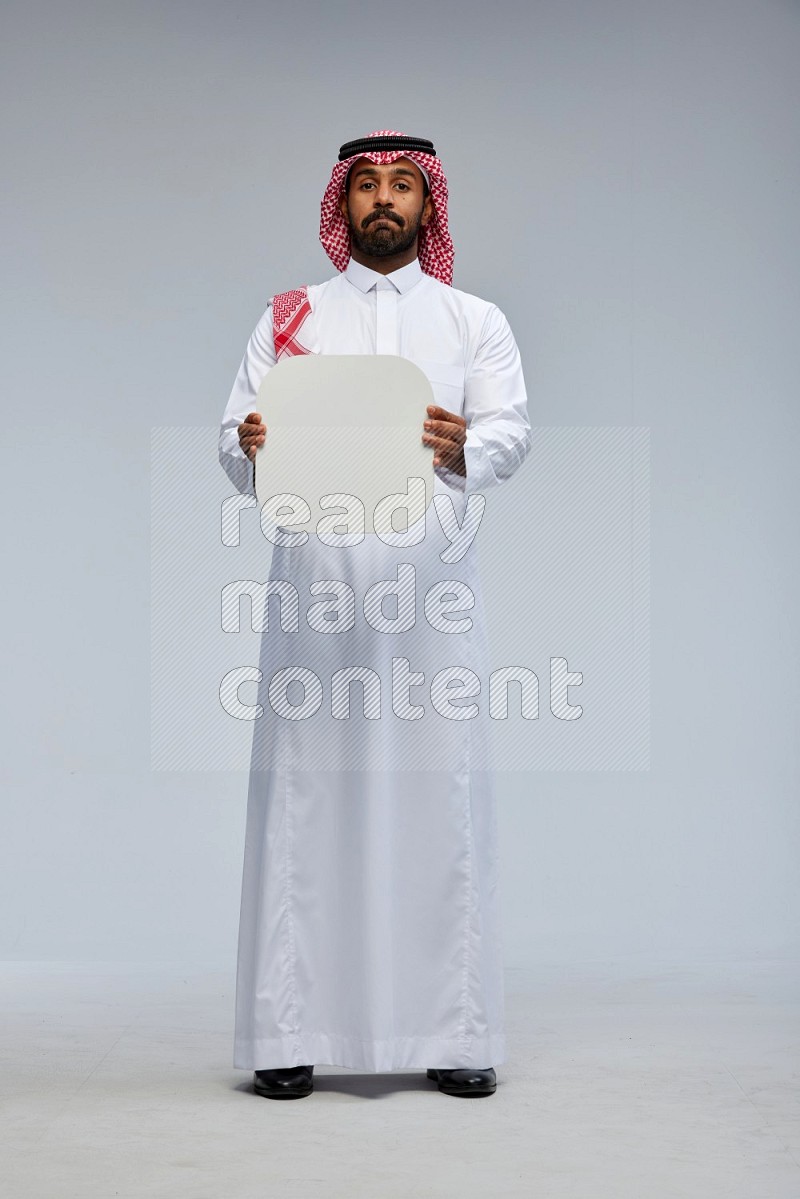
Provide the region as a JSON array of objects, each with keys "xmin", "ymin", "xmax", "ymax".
[{"xmin": 339, "ymin": 158, "xmax": 433, "ymax": 258}]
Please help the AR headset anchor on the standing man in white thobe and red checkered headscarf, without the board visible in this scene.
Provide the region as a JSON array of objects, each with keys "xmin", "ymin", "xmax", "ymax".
[{"xmin": 219, "ymin": 129, "xmax": 530, "ymax": 1098}]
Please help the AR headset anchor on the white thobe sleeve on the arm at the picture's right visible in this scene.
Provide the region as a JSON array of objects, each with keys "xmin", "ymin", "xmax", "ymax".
[{"xmin": 437, "ymin": 305, "xmax": 531, "ymax": 492}]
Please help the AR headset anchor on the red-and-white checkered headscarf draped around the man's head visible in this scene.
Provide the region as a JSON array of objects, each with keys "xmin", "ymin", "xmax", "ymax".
[{"xmin": 319, "ymin": 129, "xmax": 455, "ymax": 287}]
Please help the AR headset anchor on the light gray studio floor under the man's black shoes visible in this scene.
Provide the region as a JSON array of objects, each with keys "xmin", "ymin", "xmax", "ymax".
[{"xmin": 0, "ymin": 960, "xmax": 800, "ymax": 1199}]
